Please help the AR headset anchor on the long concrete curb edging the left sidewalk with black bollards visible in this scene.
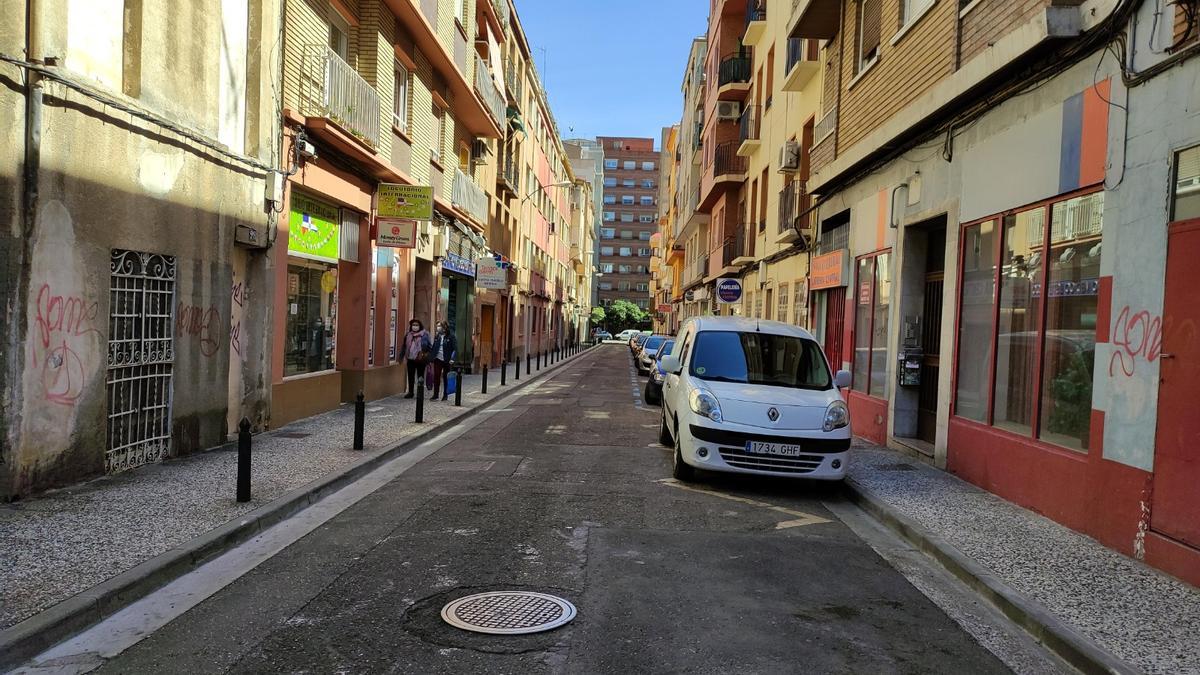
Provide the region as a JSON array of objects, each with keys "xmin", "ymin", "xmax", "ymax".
[{"xmin": 0, "ymin": 345, "xmax": 595, "ymax": 673}]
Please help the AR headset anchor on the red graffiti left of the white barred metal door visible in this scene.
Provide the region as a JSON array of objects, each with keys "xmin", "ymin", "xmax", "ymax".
[{"xmin": 30, "ymin": 283, "xmax": 100, "ymax": 406}]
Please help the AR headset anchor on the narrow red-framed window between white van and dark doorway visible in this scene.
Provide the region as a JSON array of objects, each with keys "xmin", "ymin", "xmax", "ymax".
[{"xmin": 853, "ymin": 252, "xmax": 892, "ymax": 399}]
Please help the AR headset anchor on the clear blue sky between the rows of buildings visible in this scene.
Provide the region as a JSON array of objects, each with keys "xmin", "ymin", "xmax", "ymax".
[{"xmin": 514, "ymin": 0, "xmax": 708, "ymax": 144}]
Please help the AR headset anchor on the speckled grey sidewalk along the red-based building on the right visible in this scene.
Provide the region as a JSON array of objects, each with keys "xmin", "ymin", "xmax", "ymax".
[{"xmin": 850, "ymin": 444, "xmax": 1200, "ymax": 675}]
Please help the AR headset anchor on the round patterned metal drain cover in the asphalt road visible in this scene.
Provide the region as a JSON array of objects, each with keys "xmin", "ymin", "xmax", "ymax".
[{"xmin": 442, "ymin": 591, "xmax": 575, "ymax": 635}]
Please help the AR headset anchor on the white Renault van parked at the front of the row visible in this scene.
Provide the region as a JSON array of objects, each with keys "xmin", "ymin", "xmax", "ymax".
[{"xmin": 659, "ymin": 317, "xmax": 851, "ymax": 480}]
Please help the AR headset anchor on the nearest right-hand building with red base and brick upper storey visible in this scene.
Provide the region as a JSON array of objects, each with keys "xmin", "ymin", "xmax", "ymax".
[{"xmin": 787, "ymin": 0, "xmax": 1200, "ymax": 584}]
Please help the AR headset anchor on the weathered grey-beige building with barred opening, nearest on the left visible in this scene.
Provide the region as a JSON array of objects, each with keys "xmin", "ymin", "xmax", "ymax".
[{"xmin": 0, "ymin": 0, "xmax": 281, "ymax": 501}]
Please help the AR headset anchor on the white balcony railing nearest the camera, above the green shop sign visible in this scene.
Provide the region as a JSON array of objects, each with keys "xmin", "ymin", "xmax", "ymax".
[{"xmin": 300, "ymin": 44, "xmax": 376, "ymax": 148}]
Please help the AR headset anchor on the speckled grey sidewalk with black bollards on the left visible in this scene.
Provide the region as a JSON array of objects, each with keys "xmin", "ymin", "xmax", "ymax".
[{"xmin": 0, "ymin": 352, "xmax": 588, "ymax": 629}]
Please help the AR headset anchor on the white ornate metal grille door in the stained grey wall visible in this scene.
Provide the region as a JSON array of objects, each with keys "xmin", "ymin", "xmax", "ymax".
[{"xmin": 104, "ymin": 249, "xmax": 175, "ymax": 473}]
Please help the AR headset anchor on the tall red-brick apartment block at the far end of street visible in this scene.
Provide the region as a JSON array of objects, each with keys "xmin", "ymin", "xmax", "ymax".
[{"xmin": 596, "ymin": 136, "xmax": 659, "ymax": 311}]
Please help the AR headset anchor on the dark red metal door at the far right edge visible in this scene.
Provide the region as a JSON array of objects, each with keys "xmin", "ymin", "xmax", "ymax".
[{"xmin": 1146, "ymin": 220, "xmax": 1200, "ymax": 546}]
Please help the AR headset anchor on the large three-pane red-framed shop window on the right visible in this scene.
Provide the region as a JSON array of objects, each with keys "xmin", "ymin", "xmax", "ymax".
[{"xmin": 954, "ymin": 192, "xmax": 1104, "ymax": 450}]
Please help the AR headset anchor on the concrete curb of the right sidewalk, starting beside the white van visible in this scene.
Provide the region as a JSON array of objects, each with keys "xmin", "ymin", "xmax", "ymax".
[{"xmin": 845, "ymin": 478, "xmax": 1142, "ymax": 675}]
